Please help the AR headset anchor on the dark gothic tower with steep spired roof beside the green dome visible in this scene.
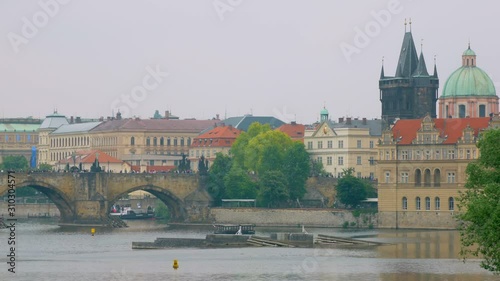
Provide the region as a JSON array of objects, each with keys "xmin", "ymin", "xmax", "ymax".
[{"xmin": 379, "ymin": 23, "xmax": 439, "ymax": 125}]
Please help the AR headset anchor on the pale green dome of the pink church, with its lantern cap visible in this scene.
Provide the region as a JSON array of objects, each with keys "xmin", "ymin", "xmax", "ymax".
[{"xmin": 441, "ymin": 65, "xmax": 496, "ymax": 97}]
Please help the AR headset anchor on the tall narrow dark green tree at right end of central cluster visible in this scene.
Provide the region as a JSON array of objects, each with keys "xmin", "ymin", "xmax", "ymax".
[{"xmin": 283, "ymin": 141, "xmax": 310, "ymax": 200}]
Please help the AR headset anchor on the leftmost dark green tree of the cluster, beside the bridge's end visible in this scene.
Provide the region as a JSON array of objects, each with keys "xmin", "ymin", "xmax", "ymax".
[{"xmin": 207, "ymin": 152, "xmax": 233, "ymax": 206}]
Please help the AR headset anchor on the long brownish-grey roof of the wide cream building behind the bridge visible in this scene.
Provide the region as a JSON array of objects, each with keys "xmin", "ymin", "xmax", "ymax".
[{"xmin": 92, "ymin": 118, "xmax": 220, "ymax": 133}]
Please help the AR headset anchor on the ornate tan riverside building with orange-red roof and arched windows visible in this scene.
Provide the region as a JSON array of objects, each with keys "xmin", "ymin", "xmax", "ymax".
[{"xmin": 377, "ymin": 115, "xmax": 500, "ymax": 229}]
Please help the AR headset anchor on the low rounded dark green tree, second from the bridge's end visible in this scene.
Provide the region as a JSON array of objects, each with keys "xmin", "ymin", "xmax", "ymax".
[{"xmin": 224, "ymin": 165, "xmax": 257, "ymax": 199}]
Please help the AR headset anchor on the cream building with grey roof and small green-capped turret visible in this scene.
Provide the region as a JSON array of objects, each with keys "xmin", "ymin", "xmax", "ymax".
[{"xmin": 304, "ymin": 108, "xmax": 382, "ymax": 179}]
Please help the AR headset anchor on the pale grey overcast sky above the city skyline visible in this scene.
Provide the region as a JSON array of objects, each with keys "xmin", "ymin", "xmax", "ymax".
[{"xmin": 0, "ymin": 0, "xmax": 500, "ymax": 123}]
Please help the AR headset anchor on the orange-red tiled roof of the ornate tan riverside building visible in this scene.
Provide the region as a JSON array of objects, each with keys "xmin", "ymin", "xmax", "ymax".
[{"xmin": 392, "ymin": 117, "xmax": 490, "ymax": 144}]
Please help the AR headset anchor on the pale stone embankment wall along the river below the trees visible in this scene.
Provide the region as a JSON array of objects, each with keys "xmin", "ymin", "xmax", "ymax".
[{"xmin": 210, "ymin": 208, "xmax": 378, "ymax": 227}]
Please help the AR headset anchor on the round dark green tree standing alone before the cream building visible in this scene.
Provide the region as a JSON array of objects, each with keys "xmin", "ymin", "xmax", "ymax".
[{"xmin": 336, "ymin": 168, "xmax": 368, "ymax": 208}]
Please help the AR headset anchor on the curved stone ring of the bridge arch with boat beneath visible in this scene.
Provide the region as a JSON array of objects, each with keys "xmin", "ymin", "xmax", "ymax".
[{"xmin": 107, "ymin": 185, "xmax": 187, "ymax": 221}]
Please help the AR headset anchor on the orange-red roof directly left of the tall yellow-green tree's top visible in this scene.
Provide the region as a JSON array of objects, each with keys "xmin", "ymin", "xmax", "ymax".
[{"xmin": 191, "ymin": 126, "xmax": 241, "ymax": 147}]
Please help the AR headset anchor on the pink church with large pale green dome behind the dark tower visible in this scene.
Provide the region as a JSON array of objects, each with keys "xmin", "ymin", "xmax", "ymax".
[{"xmin": 439, "ymin": 44, "xmax": 498, "ymax": 118}]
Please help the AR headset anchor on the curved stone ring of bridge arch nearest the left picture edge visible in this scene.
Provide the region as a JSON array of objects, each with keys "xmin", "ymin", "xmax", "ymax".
[{"xmin": 0, "ymin": 181, "xmax": 76, "ymax": 222}]
